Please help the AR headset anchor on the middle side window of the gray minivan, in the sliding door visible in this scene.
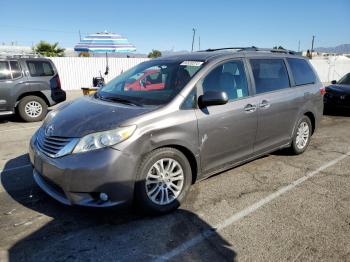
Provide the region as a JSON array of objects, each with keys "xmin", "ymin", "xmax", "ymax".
[{"xmin": 250, "ymin": 59, "xmax": 290, "ymax": 94}]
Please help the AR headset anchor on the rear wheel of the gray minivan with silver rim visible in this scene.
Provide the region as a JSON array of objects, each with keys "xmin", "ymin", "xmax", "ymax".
[{"xmin": 290, "ymin": 116, "xmax": 312, "ymax": 155}]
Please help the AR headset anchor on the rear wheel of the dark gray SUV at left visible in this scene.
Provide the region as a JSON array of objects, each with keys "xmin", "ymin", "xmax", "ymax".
[{"xmin": 18, "ymin": 96, "xmax": 47, "ymax": 122}]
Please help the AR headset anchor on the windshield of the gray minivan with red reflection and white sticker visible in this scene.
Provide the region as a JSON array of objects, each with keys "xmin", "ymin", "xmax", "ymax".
[{"xmin": 95, "ymin": 59, "xmax": 203, "ymax": 106}]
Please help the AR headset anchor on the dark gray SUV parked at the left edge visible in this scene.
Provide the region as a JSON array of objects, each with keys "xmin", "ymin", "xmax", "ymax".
[{"xmin": 0, "ymin": 57, "xmax": 66, "ymax": 122}]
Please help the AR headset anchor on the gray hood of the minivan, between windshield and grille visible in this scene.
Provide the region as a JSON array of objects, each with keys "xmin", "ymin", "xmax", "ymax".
[{"xmin": 43, "ymin": 96, "xmax": 154, "ymax": 137}]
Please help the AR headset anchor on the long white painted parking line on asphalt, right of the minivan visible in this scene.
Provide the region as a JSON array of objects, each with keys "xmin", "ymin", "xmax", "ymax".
[{"xmin": 155, "ymin": 151, "xmax": 350, "ymax": 262}]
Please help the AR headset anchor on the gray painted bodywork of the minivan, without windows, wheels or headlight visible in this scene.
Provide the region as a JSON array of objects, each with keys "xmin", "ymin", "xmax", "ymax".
[{"xmin": 30, "ymin": 49, "xmax": 323, "ymax": 206}]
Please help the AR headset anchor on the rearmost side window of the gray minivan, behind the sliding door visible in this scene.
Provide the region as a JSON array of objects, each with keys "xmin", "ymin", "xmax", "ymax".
[{"xmin": 287, "ymin": 58, "xmax": 316, "ymax": 86}]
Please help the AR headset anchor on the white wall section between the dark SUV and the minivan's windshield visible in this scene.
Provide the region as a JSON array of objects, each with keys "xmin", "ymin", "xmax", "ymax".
[{"xmin": 50, "ymin": 57, "xmax": 148, "ymax": 90}]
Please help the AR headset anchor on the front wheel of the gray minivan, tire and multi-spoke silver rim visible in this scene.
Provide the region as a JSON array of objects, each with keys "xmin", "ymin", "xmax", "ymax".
[{"xmin": 135, "ymin": 147, "xmax": 192, "ymax": 214}]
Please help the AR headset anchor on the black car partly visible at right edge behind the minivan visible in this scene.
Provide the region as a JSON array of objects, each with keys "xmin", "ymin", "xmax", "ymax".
[{"xmin": 324, "ymin": 73, "xmax": 350, "ymax": 110}]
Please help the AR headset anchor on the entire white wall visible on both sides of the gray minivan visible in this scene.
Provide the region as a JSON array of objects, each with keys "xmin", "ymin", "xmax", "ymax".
[{"xmin": 51, "ymin": 57, "xmax": 350, "ymax": 90}]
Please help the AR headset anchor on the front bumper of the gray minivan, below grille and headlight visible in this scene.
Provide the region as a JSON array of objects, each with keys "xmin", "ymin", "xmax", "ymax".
[{"xmin": 29, "ymin": 139, "xmax": 137, "ymax": 207}]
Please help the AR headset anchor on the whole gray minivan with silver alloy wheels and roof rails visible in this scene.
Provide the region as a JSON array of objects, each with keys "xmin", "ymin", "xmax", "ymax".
[{"xmin": 29, "ymin": 47, "xmax": 324, "ymax": 213}]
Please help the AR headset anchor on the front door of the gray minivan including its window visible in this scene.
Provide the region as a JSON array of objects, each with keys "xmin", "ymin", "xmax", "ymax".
[{"xmin": 196, "ymin": 59, "xmax": 257, "ymax": 174}]
